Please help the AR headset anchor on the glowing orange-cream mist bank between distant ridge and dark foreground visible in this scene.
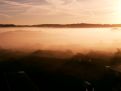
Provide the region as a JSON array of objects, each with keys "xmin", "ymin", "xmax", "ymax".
[{"xmin": 0, "ymin": 28, "xmax": 121, "ymax": 51}]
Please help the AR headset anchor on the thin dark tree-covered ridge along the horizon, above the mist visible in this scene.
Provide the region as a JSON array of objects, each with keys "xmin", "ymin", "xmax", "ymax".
[{"xmin": 0, "ymin": 23, "xmax": 121, "ymax": 28}]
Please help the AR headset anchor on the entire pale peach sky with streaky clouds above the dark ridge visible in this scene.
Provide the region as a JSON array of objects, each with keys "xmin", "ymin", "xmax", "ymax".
[{"xmin": 0, "ymin": 0, "xmax": 121, "ymax": 25}]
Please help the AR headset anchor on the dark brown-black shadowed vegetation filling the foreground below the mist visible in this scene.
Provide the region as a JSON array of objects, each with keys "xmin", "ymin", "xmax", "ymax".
[{"xmin": 0, "ymin": 49, "xmax": 121, "ymax": 91}]
